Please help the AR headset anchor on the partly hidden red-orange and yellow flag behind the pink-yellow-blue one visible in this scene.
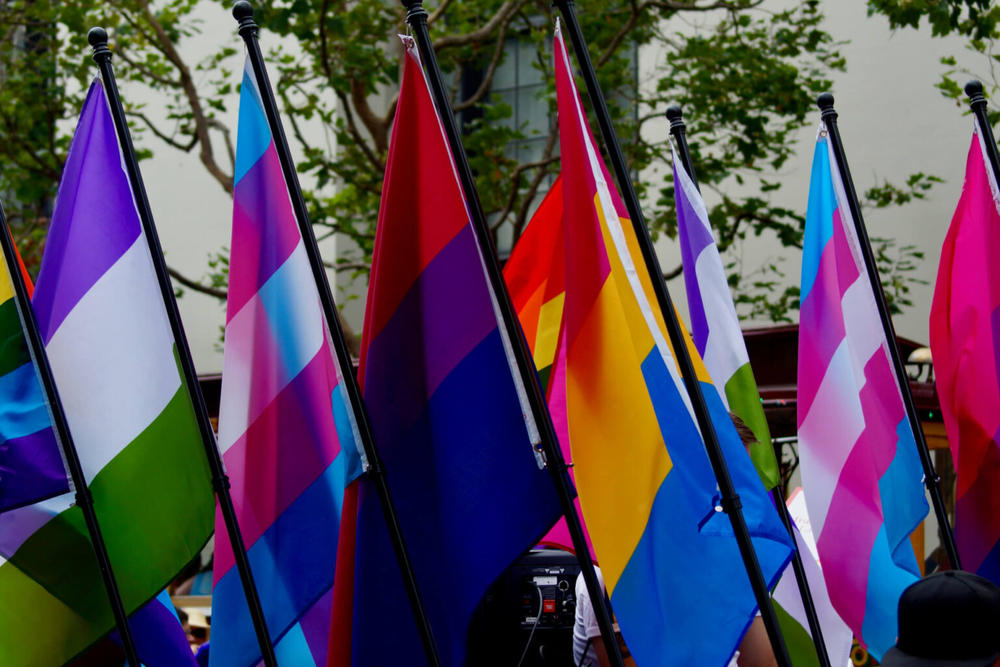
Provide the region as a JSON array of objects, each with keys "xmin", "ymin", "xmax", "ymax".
[{"xmin": 503, "ymin": 178, "xmax": 593, "ymax": 555}]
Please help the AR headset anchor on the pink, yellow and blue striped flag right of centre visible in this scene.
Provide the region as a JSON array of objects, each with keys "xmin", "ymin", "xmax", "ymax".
[{"xmin": 554, "ymin": 20, "xmax": 791, "ymax": 665}]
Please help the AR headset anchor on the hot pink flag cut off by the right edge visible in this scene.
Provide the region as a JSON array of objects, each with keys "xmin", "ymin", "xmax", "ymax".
[{"xmin": 930, "ymin": 124, "xmax": 1000, "ymax": 584}]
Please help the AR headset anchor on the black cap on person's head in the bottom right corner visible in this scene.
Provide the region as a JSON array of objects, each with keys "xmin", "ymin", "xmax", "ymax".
[{"xmin": 882, "ymin": 570, "xmax": 1000, "ymax": 667}]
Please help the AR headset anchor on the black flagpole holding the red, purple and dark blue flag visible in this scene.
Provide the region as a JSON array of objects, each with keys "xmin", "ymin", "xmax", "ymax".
[{"xmin": 402, "ymin": 0, "xmax": 624, "ymax": 667}]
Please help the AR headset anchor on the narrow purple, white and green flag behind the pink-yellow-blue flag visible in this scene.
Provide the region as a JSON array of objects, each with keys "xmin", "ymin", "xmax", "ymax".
[{"xmin": 673, "ymin": 152, "xmax": 781, "ymax": 489}]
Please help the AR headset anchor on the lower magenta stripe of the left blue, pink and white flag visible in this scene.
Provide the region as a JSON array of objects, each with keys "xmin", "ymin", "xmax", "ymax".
[{"xmin": 215, "ymin": 346, "xmax": 340, "ymax": 582}]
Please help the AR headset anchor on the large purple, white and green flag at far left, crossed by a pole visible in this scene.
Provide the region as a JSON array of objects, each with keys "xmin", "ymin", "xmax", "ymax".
[{"xmin": 0, "ymin": 81, "xmax": 212, "ymax": 665}]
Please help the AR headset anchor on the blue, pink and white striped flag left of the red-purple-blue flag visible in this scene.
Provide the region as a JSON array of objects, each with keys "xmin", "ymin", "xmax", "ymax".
[{"xmin": 209, "ymin": 60, "xmax": 362, "ymax": 667}]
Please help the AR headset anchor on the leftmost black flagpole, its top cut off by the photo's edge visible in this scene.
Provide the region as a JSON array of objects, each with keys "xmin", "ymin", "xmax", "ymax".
[{"xmin": 0, "ymin": 204, "xmax": 140, "ymax": 667}]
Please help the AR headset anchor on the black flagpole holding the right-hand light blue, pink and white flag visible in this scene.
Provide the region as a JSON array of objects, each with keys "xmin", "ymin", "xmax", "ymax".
[{"xmin": 816, "ymin": 93, "xmax": 960, "ymax": 570}]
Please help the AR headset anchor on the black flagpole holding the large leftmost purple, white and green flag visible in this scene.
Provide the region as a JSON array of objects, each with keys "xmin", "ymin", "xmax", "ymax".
[{"xmin": 87, "ymin": 28, "xmax": 277, "ymax": 667}]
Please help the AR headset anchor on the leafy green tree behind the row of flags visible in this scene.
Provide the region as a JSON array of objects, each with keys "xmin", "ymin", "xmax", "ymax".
[{"xmin": 0, "ymin": 0, "xmax": 919, "ymax": 320}]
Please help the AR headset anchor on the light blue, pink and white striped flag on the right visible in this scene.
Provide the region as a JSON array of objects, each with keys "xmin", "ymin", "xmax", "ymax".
[{"xmin": 798, "ymin": 124, "xmax": 927, "ymax": 658}]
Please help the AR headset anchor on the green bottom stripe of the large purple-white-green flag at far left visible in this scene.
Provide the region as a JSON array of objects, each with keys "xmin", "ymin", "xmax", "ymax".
[{"xmin": 0, "ymin": 374, "xmax": 214, "ymax": 665}]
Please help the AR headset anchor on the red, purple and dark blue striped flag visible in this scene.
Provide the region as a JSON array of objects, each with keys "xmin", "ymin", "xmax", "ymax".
[{"xmin": 335, "ymin": 37, "xmax": 559, "ymax": 665}]
